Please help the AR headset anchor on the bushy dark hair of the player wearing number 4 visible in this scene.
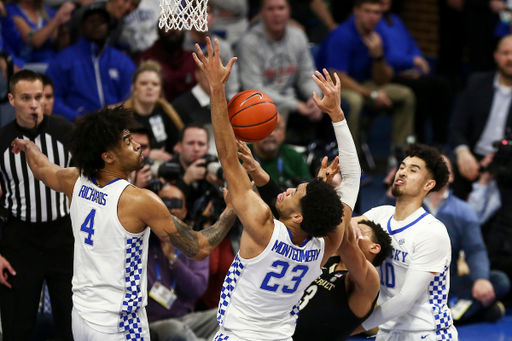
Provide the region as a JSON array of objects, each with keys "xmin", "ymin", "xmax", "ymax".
[{"xmin": 70, "ymin": 105, "xmax": 137, "ymax": 178}]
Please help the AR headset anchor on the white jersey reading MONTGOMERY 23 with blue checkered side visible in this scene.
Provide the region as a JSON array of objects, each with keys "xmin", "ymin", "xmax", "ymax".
[{"xmin": 217, "ymin": 220, "xmax": 325, "ymax": 340}]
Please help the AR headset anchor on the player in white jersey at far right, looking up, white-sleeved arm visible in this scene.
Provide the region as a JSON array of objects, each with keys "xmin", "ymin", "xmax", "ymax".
[{"xmin": 353, "ymin": 145, "xmax": 458, "ymax": 341}]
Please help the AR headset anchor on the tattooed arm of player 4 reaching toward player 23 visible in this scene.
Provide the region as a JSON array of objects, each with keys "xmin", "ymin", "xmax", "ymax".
[{"xmin": 131, "ymin": 186, "xmax": 236, "ymax": 260}]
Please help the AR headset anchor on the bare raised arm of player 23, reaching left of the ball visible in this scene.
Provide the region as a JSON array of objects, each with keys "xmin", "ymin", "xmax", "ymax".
[{"xmin": 194, "ymin": 38, "xmax": 273, "ymax": 244}]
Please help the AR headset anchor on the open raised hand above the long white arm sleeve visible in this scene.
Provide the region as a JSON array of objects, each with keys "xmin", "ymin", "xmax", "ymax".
[{"xmin": 312, "ymin": 69, "xmax": 345, "ymax": 122}]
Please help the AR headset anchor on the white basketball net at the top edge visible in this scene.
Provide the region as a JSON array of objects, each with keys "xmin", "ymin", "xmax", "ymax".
[{"xmin": 158, "ymin": 0, "xmax": 208, "ymax": 32}]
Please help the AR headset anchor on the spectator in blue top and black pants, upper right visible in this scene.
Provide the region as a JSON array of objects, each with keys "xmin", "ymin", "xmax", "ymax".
[{"xmin": 378, "ymin": 0, "xmax": 451, "ymax": 144}]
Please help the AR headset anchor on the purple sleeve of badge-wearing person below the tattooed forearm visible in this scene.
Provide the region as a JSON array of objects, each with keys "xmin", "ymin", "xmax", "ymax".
[{"xmin": 171, "ymin": 256, "xmax": 210, "ymax": 299}]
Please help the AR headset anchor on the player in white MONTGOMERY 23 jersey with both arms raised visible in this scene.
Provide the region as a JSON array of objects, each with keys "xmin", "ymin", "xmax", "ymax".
[{"xmin": 194, "ymin": 39, "xmax": 360, "ymax": 341}]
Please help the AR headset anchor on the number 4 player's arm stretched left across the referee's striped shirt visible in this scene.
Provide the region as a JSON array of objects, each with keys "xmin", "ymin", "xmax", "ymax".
[{"xmin": 11, "ymin": 139, "xmax": 79, "ymax": 200}]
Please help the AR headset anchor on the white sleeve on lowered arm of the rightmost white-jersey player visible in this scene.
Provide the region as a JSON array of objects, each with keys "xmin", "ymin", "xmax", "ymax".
[{"xmin": 362, "ymin": 268, "xmax": 434, "ymax": 330}]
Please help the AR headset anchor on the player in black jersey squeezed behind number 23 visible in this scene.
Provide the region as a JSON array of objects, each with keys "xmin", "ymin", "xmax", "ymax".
[{"xmin": 237, "ymin": 146, "xmax": 391, "ymax": 341}]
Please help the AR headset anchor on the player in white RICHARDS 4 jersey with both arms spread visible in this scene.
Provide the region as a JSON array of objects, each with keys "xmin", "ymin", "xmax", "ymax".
[{"xmin": 12, "ymin": 107, "xmax": 236, "ymax": 341}]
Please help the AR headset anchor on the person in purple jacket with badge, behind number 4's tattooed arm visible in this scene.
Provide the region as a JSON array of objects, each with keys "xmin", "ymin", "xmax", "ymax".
[{"xmin": 146, "ymin": 185, "xmax": 218, "ymax": 341}]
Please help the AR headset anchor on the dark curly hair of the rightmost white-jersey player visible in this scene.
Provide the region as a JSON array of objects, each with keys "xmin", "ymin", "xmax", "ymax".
[{"xmin": 405, "ymin": 143, "xmax": 450, "ymax": 192}]
